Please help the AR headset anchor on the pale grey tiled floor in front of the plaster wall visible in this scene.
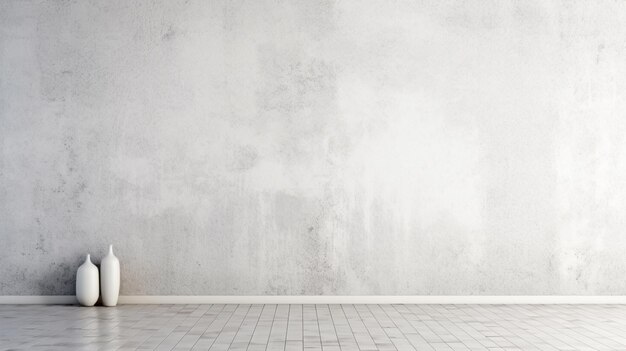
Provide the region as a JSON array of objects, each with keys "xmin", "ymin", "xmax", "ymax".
[{"xmin": 0, "ymin": 305, "xmax": 626, "ymax": 351}]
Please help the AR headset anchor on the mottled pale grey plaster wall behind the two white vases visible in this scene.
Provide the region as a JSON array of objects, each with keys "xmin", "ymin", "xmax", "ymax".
[{"xmin": 0, "ymin": 0, "xmax": 626, "ymax": 295}]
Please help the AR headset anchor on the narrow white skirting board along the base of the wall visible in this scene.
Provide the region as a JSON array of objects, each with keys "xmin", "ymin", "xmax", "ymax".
[{"xmin": 0, "ymin": 295, "xmax": 626, "ymax": 305}]
